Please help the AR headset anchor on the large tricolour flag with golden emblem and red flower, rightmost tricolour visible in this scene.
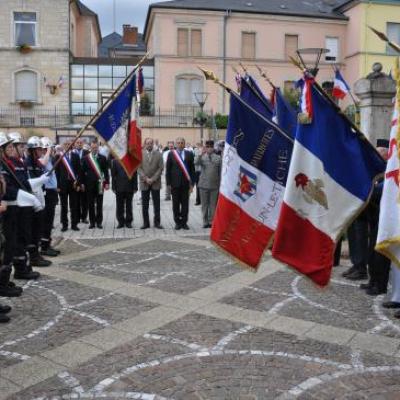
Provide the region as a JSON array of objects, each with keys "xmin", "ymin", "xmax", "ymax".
[{"xmin": 272, "ymin": 85, "xmax": 385, "ymax": 286}]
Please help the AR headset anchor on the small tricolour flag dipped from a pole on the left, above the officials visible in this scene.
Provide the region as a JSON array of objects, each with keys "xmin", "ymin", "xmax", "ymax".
[{"xmin": 92, "ymin": 75, "xmax": 142, "ymax": 177}]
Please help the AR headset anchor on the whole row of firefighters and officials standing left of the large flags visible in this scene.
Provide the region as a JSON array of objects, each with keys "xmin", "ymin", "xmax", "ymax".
[{"xmin": 0, "ymin": 132, "xmax": 221, "ymax": 323}]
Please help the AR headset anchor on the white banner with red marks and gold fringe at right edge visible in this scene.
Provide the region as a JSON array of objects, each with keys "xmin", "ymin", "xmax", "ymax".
[{"xmin": 376, "ymin": 61, "xmax": 400, "ymax": 267}]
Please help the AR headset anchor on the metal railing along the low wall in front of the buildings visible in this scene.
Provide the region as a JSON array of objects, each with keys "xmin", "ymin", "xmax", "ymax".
[{"xmin": 0, "ymin": 107, "xmax": 211, "ymax": 129}]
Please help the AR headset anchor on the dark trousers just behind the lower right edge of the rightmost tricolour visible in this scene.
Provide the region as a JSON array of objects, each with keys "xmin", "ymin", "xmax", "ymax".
[{"xmin": 347, "ymin": 213, "xmax": 369, "ymax": 271}]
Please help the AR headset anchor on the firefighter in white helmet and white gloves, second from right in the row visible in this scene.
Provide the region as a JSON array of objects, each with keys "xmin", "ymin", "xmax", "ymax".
[{"xmin": 25, "ymin": 136, "xmax": 51, "ymax": 267}]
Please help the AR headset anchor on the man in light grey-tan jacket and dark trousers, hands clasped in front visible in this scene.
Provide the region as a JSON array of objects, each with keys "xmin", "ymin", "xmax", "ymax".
[{"xmin": 138, "ymin": 138, "xmax": 164, "ymax": 229}]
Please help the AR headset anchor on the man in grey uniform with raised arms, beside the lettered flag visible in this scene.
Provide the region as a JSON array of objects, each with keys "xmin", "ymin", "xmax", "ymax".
[{"xmin": 194, "ymin": 140, "xmax": 222, "ymax": 228}]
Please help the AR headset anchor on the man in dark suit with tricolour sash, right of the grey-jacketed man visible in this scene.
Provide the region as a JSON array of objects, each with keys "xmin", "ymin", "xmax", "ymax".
[{"xmin": 165, "ymin": 138, "xmax": 195, "ymax": 230}]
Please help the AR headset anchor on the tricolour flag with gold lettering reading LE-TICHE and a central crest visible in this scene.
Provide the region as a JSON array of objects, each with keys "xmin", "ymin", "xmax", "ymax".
[{"xmin": 211, "ymin": 94, "xmax": 293, "ymax": 269}]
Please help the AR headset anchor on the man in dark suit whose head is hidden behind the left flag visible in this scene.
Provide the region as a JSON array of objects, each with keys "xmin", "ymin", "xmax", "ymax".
[{"xmin": 111, "ymin": 160, "xmax": 138, "ymax": 229}]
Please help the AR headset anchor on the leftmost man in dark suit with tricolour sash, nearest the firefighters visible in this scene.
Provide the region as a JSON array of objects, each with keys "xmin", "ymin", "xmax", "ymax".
[{"xmin": 54, "ymin": 140, "xmax": 81, "ymax": 232}]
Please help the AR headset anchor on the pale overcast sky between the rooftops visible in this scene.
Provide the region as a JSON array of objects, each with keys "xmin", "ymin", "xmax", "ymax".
[{"xmin": 81, "ymin": 0, "xmax": 161, "ymax": 37}]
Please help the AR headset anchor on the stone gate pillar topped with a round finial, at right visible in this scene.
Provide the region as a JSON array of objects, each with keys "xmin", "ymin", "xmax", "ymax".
[{"xmin": 354, "ymin": 63, "xmax": 396, "ymax": 146}]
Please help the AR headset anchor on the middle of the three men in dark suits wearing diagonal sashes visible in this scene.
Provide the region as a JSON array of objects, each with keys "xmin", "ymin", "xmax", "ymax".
[{"xmin": 82, "ymin": 139, "xmax": 110, "ymax": 229}]
